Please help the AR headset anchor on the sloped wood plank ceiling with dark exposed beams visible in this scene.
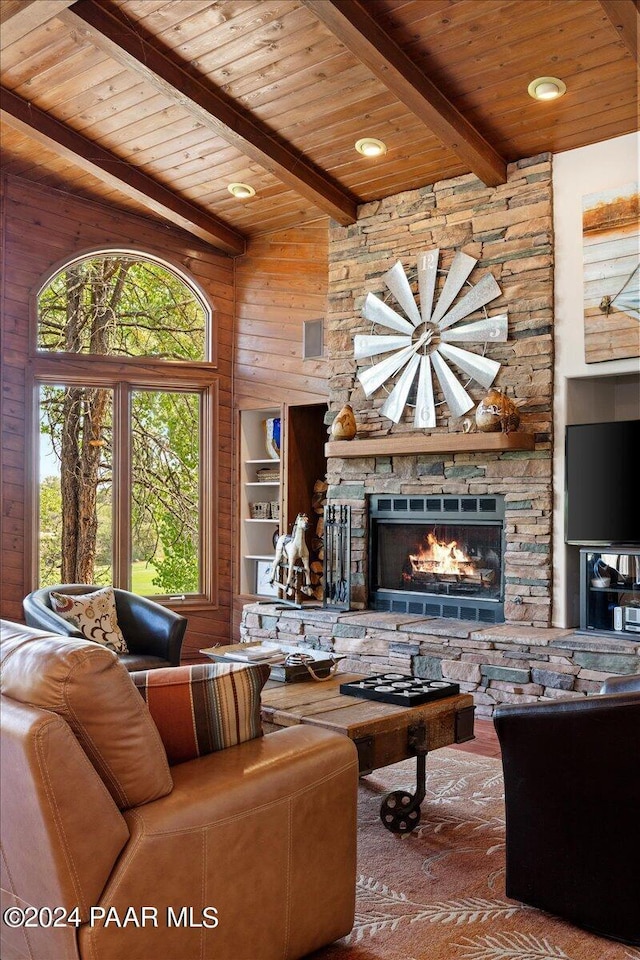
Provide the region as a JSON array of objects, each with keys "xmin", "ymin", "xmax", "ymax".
[{"xmin": 0, "ymin": 0, "xmax": 640, "ymax": 255}]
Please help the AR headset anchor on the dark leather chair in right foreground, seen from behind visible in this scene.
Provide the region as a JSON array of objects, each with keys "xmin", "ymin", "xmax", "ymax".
[{"xmin": 494, "ymin": 676, "xmax": 640, "ymax": 944}]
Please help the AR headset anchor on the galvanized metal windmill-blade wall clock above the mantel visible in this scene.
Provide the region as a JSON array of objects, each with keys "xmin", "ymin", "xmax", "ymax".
[{"xmin": 354, "ymin": 250, "xmax": 507, "ymax": 428}]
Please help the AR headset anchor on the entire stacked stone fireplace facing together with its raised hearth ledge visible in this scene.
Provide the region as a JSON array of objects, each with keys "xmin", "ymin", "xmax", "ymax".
[{"xmin": 241, "ymin": 155, "xmax": 640, "ymax": 716}]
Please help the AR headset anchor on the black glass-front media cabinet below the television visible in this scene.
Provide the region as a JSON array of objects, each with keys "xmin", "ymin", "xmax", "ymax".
[{"xmin": 580, "ymin": 543, "xmax": 640, "ymax": 640}]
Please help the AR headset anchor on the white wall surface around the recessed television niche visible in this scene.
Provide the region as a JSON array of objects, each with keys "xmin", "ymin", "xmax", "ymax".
[{"xmin": 553, "ymin": 134, "xmax": 640, "ymax": 627}]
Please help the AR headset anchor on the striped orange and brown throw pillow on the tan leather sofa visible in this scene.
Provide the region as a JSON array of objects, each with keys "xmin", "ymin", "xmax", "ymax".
[{"xmin": 131, "ymin": 663, "xmax": 270, "ymax": 764}]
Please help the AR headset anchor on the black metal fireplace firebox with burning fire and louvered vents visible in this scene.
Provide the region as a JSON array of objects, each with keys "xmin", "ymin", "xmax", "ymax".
[{"xmin": 369, "ymin": 495, "xmax": 504, "ymax": 623}]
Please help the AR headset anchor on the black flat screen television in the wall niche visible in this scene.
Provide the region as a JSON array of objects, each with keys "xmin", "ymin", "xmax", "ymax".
[{"xmin": 565, "ymin": 420, "xmax": 640, "ymax": 546}]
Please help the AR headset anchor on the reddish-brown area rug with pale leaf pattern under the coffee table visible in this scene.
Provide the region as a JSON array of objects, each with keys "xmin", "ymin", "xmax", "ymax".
[{"xmin": 313, "ymin": 749, "xmax": 640, "ymax": 960}]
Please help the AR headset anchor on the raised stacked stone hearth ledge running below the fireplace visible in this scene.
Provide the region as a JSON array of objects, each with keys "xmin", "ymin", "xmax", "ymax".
[{"xmin": 240, "ymin": 602, "xmax": 640, "ymax": 717}]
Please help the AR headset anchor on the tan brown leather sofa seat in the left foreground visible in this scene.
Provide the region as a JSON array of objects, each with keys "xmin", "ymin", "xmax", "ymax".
[{"xmin": 0, "ymin": 621, "xmax": 358, "ymax": 960}]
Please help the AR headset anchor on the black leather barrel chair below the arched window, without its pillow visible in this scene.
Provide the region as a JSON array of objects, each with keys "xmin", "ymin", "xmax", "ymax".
[{"xmin": 22, "ymin": 583, "xmax": 187, "ymax": 671}]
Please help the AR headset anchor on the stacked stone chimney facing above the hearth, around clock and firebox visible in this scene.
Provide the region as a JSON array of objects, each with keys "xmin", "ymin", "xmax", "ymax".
[{"xmin": 326, "ymin": 154, "xmax": 553, "ymax": 627}]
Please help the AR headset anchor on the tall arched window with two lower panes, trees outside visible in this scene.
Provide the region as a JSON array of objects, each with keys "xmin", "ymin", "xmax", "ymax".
[{"xmin": 36, "ymin": 250, "xmax": 215, "ymax": 602}]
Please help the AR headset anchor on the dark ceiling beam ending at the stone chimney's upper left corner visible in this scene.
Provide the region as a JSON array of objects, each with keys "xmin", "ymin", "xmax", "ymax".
[{"xmin": 61, "ymin": 0, "xmax": 358, "ymax": 226}]
